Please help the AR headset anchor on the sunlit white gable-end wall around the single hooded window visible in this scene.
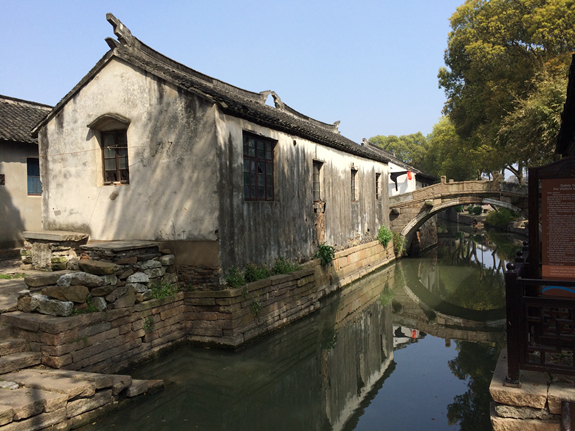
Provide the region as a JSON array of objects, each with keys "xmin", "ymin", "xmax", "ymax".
[{"xmin": 39, "ymin": 59, "xmax": 218, "ymax": 246}]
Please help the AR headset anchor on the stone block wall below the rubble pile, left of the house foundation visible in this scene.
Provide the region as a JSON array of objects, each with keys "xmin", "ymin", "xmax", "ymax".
[{"xmin": 1, "ymin": 293, "xmax": 186, "ymax": 372}]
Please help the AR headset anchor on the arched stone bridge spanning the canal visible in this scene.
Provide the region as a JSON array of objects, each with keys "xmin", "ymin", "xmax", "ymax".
[{"xmin": 389, "ymin": 177, "xmax": 527, "ymax": 248}]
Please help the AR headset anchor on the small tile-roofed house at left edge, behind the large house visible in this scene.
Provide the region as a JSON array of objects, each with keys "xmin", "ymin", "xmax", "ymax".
[{"xmin": 0, "ymin": 95, "xmax": 52, "ymax": 249}]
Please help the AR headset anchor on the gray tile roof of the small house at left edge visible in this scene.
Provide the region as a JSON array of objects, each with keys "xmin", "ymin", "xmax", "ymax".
[{"xmin": 0, "ymin": 95, "xmax": 52, "ymax": 143}]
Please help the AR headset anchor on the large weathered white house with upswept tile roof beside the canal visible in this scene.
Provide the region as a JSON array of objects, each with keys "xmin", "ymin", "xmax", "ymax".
[{"xmin": 34, "ymin": 14, "xmax": 396, "ymax": 280}]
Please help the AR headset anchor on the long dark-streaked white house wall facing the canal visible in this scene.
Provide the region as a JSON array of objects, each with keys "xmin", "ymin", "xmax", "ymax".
[{"xmin": 217, "ymin": 112, "xmax": 389, "ymax": 270}]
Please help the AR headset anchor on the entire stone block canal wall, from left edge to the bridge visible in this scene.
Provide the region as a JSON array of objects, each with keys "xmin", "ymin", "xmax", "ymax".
[{"xmin": 1, "ymin": 241, "xmax": 395, "ymax": 372}]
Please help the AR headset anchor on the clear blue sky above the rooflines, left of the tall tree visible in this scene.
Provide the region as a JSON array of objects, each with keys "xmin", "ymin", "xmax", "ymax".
[{"xmin": 0, "ymin": 0, "xmax": 463, "ymax": 143}]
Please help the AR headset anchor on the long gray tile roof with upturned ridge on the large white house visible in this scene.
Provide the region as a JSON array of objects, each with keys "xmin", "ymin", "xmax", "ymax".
[{"xmin": 34, "ymin": 14, "xmax": 396, "ymax": 163}]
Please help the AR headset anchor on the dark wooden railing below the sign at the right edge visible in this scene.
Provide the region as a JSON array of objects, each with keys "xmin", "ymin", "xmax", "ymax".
[{"xmin": 505, "ymin": 244, "xmax": 575, "ymax": 384}]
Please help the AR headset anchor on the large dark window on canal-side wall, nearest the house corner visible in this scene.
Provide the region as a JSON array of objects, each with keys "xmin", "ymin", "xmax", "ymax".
[{"xmin": 243, "ymin": 132, "xmax": 277, "ymax": 201}]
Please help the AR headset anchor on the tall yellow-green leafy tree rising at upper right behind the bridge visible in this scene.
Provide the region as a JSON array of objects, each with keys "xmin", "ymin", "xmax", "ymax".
[{"xmin": 438, "ymin": 0, "xmax": 575, "ymax": 181}]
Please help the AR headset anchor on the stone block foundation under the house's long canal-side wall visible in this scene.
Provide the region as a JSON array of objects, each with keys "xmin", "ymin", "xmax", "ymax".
[{"xmin": 185, "ymin": 241, "xmax": 395, "ymax": 347}]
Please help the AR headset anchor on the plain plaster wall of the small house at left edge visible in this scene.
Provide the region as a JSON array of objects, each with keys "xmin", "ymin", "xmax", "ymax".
[{"xmin": 0, "ymin": 142, "xmax": 42, "ymax": 248}]
